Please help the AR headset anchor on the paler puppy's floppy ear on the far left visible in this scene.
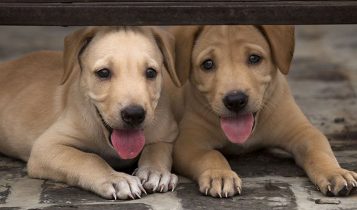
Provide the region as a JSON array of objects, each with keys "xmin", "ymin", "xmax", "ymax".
[{"xmin": 61, "ymin": 27, "xmax": 97, "ymax": 84}]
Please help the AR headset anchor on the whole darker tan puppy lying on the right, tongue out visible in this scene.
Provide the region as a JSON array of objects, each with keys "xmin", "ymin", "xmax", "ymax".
[{"xmin": 171, "ymin": 26, "xmax": 357, "ymax": 197}]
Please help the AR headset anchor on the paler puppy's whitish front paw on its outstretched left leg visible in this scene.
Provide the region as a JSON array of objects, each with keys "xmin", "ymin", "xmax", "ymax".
[{"xmin": 96, "ymin": 172, "xmax": 145, "ymax": 200}]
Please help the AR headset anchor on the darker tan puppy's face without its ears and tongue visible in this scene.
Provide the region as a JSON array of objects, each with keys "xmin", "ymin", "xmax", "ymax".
[{"xmin": 191, "ymin": 26, "xmax": 276, "ymax": 118}]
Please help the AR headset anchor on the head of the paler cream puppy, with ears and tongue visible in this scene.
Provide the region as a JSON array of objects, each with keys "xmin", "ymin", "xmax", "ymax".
[{"xmin": 63, "ymin": 27, "xmax": 179, "ymax": 159}]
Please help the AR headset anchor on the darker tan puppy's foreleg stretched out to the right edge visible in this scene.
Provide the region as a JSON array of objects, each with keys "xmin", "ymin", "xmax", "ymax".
[{"xmin": 265, "ymin": 96, "xmax": 357, "ymax": 196}]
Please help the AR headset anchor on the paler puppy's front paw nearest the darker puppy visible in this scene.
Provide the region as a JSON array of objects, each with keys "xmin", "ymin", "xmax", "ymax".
[{"xmin": 133, "ymin": 167, "xmax": 178, "ymax": 192}]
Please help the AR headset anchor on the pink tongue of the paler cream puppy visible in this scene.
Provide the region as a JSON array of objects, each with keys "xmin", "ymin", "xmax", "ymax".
[{"xmin": 111, "ymin": 130, "xmax": 145, "ymax": 159}]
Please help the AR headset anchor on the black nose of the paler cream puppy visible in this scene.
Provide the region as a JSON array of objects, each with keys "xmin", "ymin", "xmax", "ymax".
[{"xmin": 121, "ymin": 105, "xmax": 146, "ymax": 126}]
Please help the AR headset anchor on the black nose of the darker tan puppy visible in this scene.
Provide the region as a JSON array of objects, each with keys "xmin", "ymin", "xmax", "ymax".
[{"xmin": 223, "ymin": 91, "xmax": 248, "ymax": 112}]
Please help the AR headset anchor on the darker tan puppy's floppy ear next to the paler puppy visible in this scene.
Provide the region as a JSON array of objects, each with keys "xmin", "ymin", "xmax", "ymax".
[{"xmin": 169, "ymin": 26, "xmax": 203, "ymax": 84}]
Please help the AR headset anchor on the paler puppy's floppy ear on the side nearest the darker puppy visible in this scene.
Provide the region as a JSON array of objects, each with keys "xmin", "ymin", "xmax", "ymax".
[{"xmin": 151, "ymin": 27, "xmax": 182, "ymax": 87}]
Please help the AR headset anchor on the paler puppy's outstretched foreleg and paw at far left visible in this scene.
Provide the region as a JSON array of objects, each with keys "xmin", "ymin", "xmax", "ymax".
[{"xmin": 27, "ymin": 135, "xmax": 142, "ymax": 199}]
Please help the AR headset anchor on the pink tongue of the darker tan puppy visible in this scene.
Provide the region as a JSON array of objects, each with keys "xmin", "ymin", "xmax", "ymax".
[{"xmin": 221, "ymin": 113, "xmax": 254, "ymax": 144}]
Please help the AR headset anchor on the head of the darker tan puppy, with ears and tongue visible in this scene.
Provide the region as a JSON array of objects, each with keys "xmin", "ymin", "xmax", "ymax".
[{"xmin": 172, "ymin": 26, "xmax": 294, "ymax": 143}]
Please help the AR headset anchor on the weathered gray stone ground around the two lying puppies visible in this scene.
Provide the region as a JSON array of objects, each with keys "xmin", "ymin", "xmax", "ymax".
[{"xmin": 0, "ymin": 25, "xmax": 357, "ymax": 210}]
